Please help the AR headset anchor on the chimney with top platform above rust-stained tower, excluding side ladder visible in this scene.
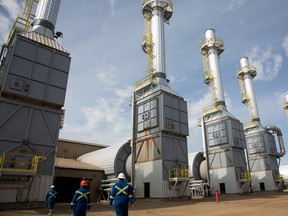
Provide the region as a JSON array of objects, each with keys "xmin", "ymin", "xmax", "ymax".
[{"xmin": 142, "ymin": 0, "xmax": 173, "ymax": 85}]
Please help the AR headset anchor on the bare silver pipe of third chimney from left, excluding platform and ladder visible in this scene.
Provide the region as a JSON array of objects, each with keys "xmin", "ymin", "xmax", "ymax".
[{"xmin": 205, "ymin": 29, "xmax": 225, "ymax": 104}]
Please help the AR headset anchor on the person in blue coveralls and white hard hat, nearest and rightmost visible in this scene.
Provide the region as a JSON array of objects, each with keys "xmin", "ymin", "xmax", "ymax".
[{"xmin": 109, "ymin": 173, "xmax": 134, "ymax": 216}]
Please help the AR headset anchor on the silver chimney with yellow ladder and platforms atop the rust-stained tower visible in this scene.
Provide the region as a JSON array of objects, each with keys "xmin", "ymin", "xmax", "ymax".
[{"xmin": 142, "ymin": 0, "xmax": 173, "ymax": 85}]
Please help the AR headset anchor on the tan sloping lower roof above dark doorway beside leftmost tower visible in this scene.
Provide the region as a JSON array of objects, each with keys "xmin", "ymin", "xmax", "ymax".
[{"xmin": 55, "ymin": 157, "xmax": 103, "ymax": 170}]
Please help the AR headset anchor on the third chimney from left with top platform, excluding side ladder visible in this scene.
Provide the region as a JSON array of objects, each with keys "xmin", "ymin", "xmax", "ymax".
[{"xmin": 200, "ymin": 29, "xmax": 225, "ymax": 106}]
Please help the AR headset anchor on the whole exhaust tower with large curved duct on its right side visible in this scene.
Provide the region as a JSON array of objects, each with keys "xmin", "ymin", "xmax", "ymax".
[{"xmin": 236, "ymin": 57, "xmax": 285, "ymax": 191}]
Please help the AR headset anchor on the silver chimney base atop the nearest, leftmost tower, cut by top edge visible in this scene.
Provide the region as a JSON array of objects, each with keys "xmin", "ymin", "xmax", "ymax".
[{"xmin": 32, "ymin": 0, "xmax": 61, "ymax": 38}]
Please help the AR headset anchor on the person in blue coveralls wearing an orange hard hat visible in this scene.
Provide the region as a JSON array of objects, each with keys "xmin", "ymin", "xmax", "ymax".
[{"xmin": 70, "ymin": 180, "xmax": 92, "ymax": 216}]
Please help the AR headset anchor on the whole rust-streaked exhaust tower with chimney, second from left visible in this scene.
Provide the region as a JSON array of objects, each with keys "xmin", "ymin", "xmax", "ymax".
[{"xmin": 133, "ymin": 0, "xmax": 189, "ymax": 199}]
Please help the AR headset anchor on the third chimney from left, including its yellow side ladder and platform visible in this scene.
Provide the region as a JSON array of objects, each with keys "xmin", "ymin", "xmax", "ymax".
[{"xmin": 200, "ymin": 29, "xmax": 226, "ymax": 109}]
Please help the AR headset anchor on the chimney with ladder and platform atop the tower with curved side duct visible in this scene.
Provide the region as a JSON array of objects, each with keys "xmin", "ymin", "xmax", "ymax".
[{"xmin": 237, "ymin": 57, "xmax": 260, "ymax": 122}]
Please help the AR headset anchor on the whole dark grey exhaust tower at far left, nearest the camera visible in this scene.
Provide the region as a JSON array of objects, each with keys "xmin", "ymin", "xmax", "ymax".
[{"xmin": 0, "ymin": 0, "xmax": 71, "ymax": 207}]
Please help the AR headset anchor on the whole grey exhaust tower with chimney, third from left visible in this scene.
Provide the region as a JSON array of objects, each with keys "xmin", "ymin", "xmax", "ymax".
[{"xmin": 200, "ymin": 29, "xmax": 251, "ymax": 194}]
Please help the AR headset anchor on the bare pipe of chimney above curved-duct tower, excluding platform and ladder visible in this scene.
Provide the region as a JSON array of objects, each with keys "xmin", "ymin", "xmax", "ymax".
[{"xmin": 240, "ymin": 57, "xmax": 260, "ymax": 121}]
